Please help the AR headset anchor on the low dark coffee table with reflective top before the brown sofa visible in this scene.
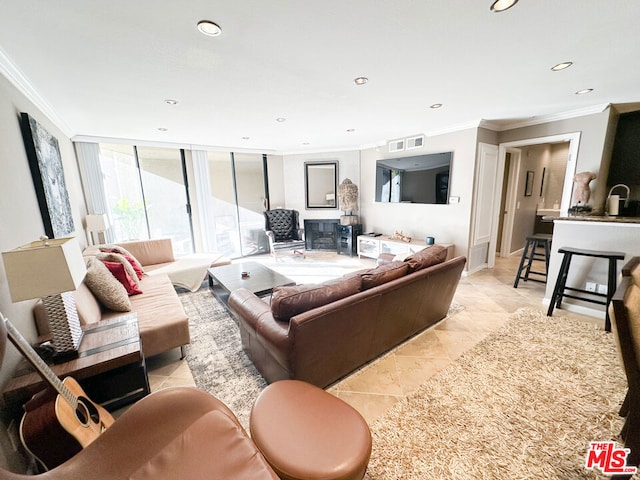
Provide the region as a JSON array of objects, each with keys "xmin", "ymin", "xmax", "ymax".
[{"xmin": 208, "ymin": 262, "xmax": 296, "ymax": 306}]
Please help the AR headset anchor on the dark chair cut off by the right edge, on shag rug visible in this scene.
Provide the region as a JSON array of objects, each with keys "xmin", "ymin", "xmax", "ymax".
[{"xmin": 609, "ymin": 257, "xmax": 640, "ymax": 479}]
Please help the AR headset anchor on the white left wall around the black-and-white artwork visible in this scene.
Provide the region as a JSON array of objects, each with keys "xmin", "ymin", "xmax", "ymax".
[{"xmin": 0, "ymin": 75, "xmax": 86, "ymax": 471}]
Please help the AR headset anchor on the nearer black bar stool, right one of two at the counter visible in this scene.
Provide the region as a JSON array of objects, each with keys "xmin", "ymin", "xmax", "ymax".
[{"xmin": 547, "ymin": 247, "xmax": 624, "ymax": 332}]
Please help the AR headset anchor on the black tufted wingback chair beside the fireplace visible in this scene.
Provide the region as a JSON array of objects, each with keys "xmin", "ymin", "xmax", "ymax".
[{"xmin": 264, "ymin": 208, "xmax": 305, "ymax": 260}]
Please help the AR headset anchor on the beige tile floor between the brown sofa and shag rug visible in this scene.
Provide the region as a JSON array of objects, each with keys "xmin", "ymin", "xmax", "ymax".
[{"xmin": 142, "ymin": 256, "xmax": 604, "ymax": 423}]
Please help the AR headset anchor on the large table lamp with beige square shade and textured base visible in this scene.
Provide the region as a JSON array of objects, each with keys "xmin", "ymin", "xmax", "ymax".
[{"xmin": 2, "ymin": 237, "xmax": 87, "ymax": 362}]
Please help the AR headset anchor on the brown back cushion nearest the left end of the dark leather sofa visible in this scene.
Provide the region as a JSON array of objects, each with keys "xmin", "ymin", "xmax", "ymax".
[{"xmin": 271, "ymin": 275, "xmax": 362, "ymax": 322}]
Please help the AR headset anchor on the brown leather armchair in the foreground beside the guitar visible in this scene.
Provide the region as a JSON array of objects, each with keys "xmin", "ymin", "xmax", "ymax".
[{"xmin": 0, "ymin": 315, "xmax": 278, "ymax": 480}]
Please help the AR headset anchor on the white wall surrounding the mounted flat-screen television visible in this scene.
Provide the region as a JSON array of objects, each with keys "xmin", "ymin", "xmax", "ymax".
[{"xmin": 360, "ymin": 128, "xmax": 477, "ymax": 256}]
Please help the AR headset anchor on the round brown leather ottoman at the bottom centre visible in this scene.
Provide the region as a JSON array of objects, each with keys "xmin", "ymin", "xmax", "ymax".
[{"xmin": 249, "ymin": 380, "xmax": 371, "ymax": 480}]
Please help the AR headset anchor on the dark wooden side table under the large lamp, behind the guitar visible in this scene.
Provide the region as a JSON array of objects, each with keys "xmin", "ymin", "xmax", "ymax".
[{"xmin": 2, "ymin": 313, "xmax": 150, "ymax": 411}]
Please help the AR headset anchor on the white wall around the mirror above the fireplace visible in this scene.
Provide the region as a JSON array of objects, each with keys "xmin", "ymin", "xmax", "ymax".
[{"xmin": 282, "ymin": 150, "xmax": 362, "ymax": 224}]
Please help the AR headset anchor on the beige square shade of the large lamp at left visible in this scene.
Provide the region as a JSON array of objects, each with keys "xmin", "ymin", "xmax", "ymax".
[{"xmin": 2, "ymin": 237, "xmax": 87, "ymax": 302}]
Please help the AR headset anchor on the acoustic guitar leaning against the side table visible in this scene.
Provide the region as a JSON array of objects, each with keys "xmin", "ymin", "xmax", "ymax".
[{"xmin": 0, "ymin": 313, "xmax": 114, "ymax": 470}]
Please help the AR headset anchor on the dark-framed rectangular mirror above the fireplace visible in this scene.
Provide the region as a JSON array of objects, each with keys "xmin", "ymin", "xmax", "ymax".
[{"xmin": 304, "ymin": 162, "xmax": 338, "ymax": 209}]
